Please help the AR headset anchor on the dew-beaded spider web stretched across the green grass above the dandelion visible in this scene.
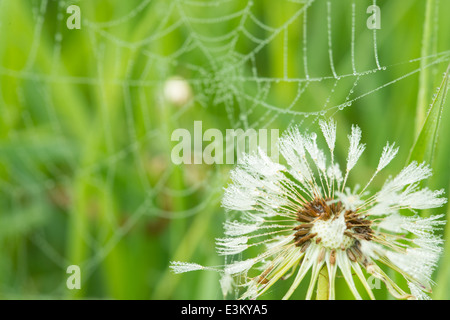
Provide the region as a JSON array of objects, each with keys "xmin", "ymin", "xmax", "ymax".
[{"xmin": 0, "ymin": 0, "xmax": 450, "ymax": 294}]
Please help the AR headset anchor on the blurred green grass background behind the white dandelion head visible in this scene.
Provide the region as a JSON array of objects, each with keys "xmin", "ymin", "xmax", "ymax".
[{"xmin": 0, "ymin": 0, "xmax": 450, "ymax": 299}]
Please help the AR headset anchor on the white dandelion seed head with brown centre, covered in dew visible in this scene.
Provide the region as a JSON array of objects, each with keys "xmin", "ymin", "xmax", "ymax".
[{"xmin": 171, "ymin": 120, "xmax": 446, "ymax": 299}]
